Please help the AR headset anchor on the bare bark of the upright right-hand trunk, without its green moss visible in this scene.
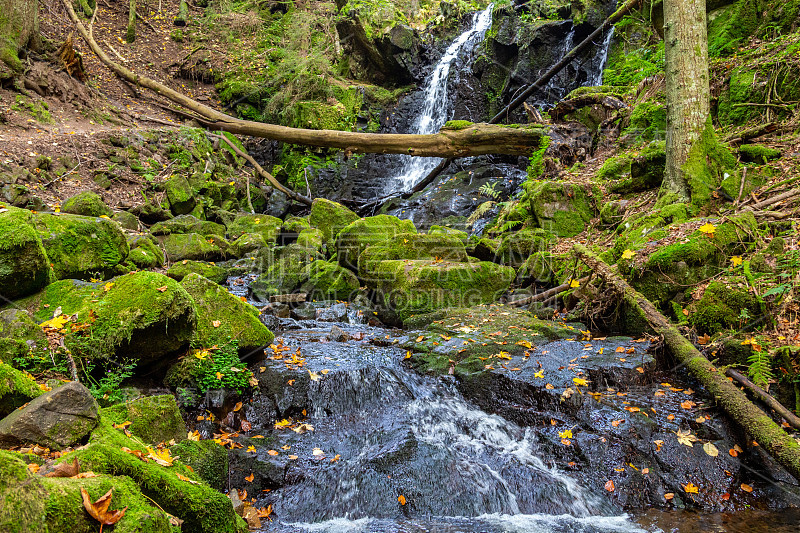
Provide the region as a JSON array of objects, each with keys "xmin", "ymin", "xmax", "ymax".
[{"xmin": 664, "ymin": 0, "xmax": 710, "ymax": 202}]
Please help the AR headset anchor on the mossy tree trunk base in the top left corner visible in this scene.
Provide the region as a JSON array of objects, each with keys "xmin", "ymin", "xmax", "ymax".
[{"xmin": 0, "ymin": 0, "xmax": 39, "ymax": 79}]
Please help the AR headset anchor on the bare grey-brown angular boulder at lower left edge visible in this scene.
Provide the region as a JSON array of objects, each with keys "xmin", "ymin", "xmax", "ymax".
[{"xmin": 0, "ymin": 381, "xmax": 99, "ymax": 450}]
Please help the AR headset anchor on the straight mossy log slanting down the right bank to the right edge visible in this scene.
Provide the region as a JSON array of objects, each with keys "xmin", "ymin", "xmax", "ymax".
[{"xmin": 573, "ymin": 244, "xmax": 800, "ymax": 480}]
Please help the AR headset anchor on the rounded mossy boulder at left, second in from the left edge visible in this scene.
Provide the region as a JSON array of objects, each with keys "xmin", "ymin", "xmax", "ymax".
[{"xmin": 34, "ymin": 213, "xmax": 130, "ymax": 279}]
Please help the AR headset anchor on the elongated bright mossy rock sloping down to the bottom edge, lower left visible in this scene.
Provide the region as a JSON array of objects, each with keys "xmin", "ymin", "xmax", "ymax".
[{"xmin": 61, "ymin": 417, "xmax": 247, "ymax": 533}]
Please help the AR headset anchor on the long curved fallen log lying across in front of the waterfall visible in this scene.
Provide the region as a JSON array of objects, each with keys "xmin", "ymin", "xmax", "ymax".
[{"xmin": 62, "ymin": 0, "xmax": 547, "ymax": 157}]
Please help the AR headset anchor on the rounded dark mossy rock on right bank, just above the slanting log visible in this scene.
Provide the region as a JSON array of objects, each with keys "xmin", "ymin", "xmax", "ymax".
[{"xmin": 689, "ymin": 281, "xmax": 760, "ymax": 335}]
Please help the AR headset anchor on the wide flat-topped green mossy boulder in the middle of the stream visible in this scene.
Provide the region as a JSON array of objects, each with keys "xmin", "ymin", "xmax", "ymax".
[{"xmin": 375, "ymin": 260, "xmax": 516, "ymax": 324}]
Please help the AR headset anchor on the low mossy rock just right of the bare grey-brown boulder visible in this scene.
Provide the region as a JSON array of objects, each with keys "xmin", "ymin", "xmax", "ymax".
[{"xmin": 100, "ymin": 394, "xmax": 187, "ymax": 444}]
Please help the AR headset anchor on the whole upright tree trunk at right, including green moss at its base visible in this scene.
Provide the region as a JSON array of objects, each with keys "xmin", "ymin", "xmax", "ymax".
[{"xmin": 661, "ymin": 0, "xmax": 733, "ymax": 208}]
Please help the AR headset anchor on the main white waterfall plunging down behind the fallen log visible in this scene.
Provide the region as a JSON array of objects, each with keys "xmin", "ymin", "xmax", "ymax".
[{"xmin": 397, "ymin": 4, "xmax": 494, "ymax": 188}]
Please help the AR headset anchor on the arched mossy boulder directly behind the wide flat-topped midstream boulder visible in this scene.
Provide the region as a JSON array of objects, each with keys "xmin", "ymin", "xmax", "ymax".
[{"xmin": 358, "ymin": 233, "xmax": 469, "ymax": 276}]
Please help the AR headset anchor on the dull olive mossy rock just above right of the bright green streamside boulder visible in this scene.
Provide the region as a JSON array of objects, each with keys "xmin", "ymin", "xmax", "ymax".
[{"xmin": 250, "ymin": 244, "xmax": 322, "ymax": 302}]
